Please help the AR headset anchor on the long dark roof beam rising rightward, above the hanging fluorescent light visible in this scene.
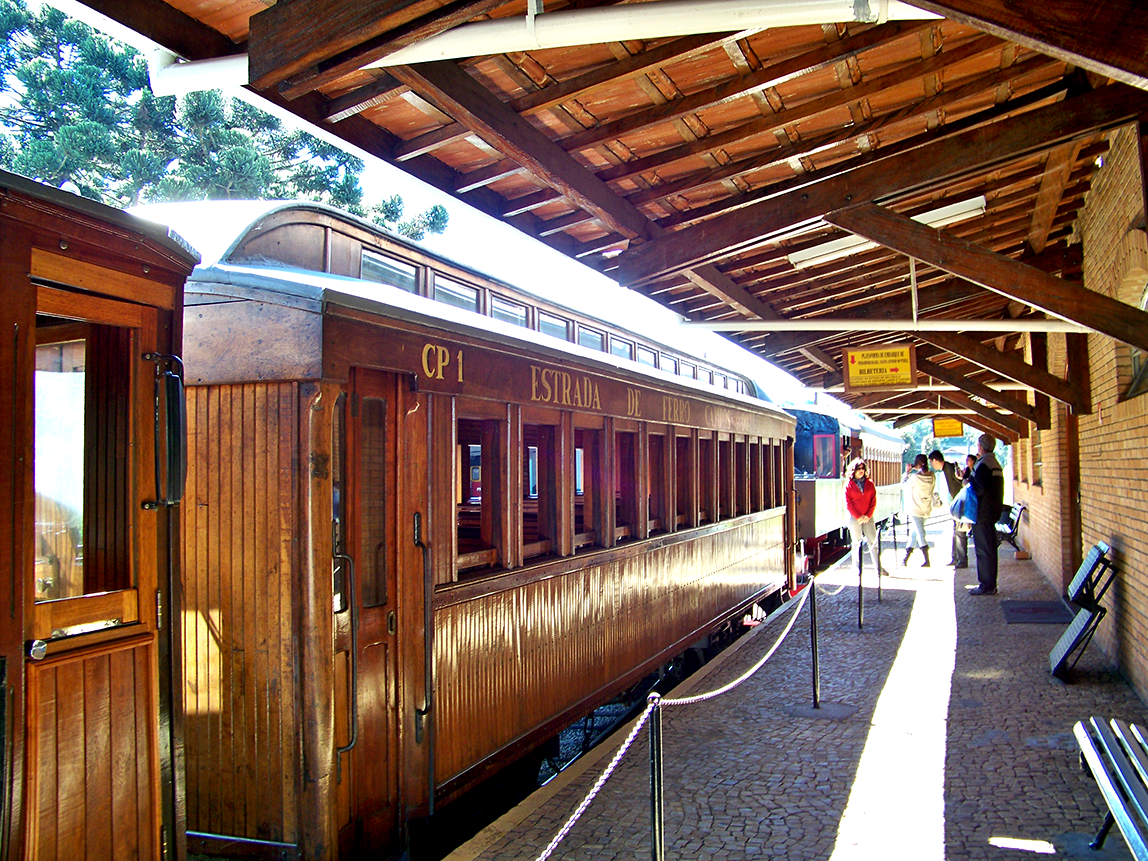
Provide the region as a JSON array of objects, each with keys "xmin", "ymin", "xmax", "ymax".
[{"xmin": 618, "ymin": 86, "xmax": 1148, "ymax": 286}]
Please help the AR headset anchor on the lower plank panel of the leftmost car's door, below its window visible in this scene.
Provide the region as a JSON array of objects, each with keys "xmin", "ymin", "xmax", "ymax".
[{"xmin": 26, "ymin": 634, "xmax": 160, "ymax": 861}]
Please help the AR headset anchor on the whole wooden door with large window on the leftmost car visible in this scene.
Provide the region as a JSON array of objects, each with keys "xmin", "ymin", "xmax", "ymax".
[{"xmin": 5, "ymin": 285, "xmax": 170, "ymax": 861}]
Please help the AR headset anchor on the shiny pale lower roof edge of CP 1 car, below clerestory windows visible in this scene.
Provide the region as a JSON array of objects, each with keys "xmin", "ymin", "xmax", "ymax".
[{"xmin": 185, "ymin": 263, "xmax": 793, "ymax": 425}]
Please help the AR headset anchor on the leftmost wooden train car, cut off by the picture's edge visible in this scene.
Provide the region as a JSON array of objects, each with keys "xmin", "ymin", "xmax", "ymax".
[{"xmin": 0, "ymin": 173, "xmax": 199, "ymax": 861}]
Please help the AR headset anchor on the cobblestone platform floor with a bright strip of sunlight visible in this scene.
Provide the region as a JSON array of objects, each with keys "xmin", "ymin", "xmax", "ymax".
[{"xmin": 449, "ymin": 521, "xmax": 1148, "ymax": 861}]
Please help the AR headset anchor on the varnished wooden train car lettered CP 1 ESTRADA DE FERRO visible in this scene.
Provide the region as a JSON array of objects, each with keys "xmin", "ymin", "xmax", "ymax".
[{"xmin": 166, "ymin": 204, "xmax": 793, "ymax": 859}]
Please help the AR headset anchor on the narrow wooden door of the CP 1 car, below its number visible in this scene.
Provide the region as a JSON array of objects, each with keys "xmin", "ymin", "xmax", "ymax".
[{"xmin": 336, "ymin": 369, "xmax": 400, "ymax": 858}]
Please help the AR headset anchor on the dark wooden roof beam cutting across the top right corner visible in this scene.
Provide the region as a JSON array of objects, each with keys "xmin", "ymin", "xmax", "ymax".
[{"xmin": 913, "ymin": 0, "xmax": 1148, "ymax": 90}]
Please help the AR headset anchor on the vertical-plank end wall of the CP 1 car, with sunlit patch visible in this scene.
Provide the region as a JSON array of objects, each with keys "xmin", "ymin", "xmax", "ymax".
[{"xmin": 181, "ymin": 382, "xmax": 300, "ymax": 843}]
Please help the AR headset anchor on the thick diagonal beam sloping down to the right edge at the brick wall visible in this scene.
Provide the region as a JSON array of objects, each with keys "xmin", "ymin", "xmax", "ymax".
[{"xmin": 825, "ymin": 203, "xmax": 1148, "ymax": 350}]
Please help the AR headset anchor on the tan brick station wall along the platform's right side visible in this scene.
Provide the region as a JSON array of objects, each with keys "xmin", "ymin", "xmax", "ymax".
[{"xmin": 1002, "ymin": 126, "xmax": 1148, "ymax": 700}]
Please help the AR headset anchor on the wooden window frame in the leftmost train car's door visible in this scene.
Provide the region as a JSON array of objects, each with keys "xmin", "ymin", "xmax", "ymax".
[{"xmin": 30, "ymin": 285, "xmax": 157, "ymax": 641}]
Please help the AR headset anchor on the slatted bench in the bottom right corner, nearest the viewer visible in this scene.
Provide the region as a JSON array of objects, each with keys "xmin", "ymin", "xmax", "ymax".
[{"xmin": 1072, "ymin": 718, "xmax": 1148, "ymax": 861}]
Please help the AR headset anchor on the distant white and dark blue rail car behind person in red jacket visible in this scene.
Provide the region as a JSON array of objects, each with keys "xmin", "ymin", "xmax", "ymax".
[{"xmin": 786, "ymin": 405, "xmax": 905, "ymax": 565}]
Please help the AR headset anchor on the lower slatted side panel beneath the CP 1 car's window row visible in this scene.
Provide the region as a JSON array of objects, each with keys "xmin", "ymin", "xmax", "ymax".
[{"xmin": 435, "ymin": 510, "xmax": 785, "ymax": 784}]
